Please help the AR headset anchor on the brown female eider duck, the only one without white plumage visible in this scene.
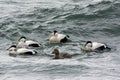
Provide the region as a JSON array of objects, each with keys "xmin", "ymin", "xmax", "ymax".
[{"xmin": 52, "ymin": 49, "xmax": 72, "ymax": 59}]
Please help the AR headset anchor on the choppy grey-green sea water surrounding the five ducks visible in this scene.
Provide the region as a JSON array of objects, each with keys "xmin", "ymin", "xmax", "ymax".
[{"xmin": 0, "ymin": 0, "xmax": 120, "ymax": 80}]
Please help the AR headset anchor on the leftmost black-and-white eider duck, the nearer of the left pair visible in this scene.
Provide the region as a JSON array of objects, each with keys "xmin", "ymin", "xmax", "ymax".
[{"xmin": 7, "ymin": 45, "xmax": 37, "ymax": 56}]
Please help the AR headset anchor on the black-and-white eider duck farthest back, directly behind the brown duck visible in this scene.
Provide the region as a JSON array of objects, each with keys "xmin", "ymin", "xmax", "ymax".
[{"xmin": 49, "ymin": 30, "xmax": 69, "ymax": 43}]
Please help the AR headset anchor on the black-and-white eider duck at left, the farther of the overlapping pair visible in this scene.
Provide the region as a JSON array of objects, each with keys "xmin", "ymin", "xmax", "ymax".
[{"xmin": 18, "ymin": 36, "xmax": 41, "ymax": 47}]
